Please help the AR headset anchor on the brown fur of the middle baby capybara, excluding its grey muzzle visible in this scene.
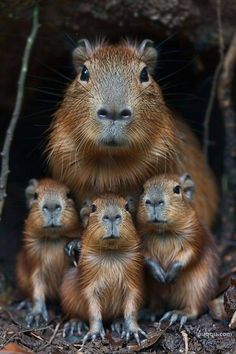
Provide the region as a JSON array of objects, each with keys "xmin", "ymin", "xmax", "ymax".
[{"xmin": 61, "ymin": 195, "xmax": 143, "ymax": 327}]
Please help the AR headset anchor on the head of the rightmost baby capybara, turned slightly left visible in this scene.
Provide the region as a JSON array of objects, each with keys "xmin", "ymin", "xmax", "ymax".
[{"xmin": 137, "ymin": 174, "xmax": 194, "ymax": 229}]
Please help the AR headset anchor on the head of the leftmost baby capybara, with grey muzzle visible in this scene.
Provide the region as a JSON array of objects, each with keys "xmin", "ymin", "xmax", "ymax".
[{"xmin": 25, "ymin": 178, "xmax": 78, "ymax": 232}]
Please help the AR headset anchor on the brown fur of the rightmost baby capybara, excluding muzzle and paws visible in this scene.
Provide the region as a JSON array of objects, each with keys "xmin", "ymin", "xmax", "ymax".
[{"xmin": 137, "ymin": 175, "xmax": 218, "ymax": 318}]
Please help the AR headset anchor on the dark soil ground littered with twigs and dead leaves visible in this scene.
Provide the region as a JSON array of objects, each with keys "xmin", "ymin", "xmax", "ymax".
[{"xmin": 0, "ymin": 247, "xmax": 236, "ymax": 354}]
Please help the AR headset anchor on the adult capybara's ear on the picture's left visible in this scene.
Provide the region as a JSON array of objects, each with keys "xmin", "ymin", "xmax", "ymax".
[{"xmin": 72, "ymin": 39, "xmax": 93, "ymax": 72}]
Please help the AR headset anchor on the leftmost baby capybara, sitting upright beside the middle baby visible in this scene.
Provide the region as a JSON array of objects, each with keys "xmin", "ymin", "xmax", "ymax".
[{"xmin": 16, "ymin": 178, "xmax": 81, "ymax": 327}]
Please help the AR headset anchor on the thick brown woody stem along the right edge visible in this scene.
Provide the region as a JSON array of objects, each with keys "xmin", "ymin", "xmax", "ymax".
[{"xmin": 218, "ymin": 30, "xmax": 236, "ymax": 239}]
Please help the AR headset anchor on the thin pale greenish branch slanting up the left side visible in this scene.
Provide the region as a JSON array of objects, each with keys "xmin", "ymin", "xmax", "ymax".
[{"xmin": 0, "ymin": 3, "xmax": 39, "ymax": 220}]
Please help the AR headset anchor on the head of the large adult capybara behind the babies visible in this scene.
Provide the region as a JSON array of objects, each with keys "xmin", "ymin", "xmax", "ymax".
[{"xmin": 55, "ymin": 40, "xmax": 171, "ymax": 154}]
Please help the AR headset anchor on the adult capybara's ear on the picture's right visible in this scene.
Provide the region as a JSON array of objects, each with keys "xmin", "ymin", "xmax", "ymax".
[{"xmin": 138, "ymin": 39, "xmax": 158, "ymax": 71}]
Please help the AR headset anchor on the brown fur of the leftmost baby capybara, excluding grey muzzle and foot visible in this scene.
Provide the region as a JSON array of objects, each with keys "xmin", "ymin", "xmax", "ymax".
[{"xmin": 16, "ymin": 179, "xmax": 81, "ymax": 301}]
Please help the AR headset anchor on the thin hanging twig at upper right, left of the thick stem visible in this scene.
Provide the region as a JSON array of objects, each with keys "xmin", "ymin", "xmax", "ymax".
[{"xmin": 203, "ymin": 0, "xmax": 224, "ymax": 164}]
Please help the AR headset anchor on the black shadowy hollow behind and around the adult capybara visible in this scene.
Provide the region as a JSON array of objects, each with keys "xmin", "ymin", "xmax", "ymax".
[{"xmin": 0, "ymin": 1, "xmax": 232, "ymax": 276}]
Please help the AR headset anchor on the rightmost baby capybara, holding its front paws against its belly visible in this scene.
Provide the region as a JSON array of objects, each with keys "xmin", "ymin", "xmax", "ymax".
[{"xmin": 137, "ymin": 174, "xmax": 218, "ymax": 326}]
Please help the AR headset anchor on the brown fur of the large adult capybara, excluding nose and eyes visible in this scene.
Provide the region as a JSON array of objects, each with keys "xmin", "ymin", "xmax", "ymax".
[{"xmin": 49, "ymin": 39, "xmax": 218, "ymax": 225}]
